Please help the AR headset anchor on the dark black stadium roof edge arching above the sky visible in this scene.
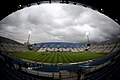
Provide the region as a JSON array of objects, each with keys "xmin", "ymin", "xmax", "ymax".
[{"xmin": 0, "ymin": 0, "xmax": 120, "ymax": 24}]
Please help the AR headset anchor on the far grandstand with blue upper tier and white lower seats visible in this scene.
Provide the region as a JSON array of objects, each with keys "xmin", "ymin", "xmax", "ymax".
[{"xmin": 35, "ymin": 42, "xmax": 85, "ymax": 52}]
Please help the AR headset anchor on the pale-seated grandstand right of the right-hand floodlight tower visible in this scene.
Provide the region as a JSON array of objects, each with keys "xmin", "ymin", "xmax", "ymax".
[{"xmin": 89, "ymin": 39, "xmax": 120, "ymax": 53}]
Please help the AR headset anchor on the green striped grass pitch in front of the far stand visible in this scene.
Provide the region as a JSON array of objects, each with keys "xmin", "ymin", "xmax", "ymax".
[{"xmin": 10, "ymin": 52, "xmax": 108, "ymax": 63}]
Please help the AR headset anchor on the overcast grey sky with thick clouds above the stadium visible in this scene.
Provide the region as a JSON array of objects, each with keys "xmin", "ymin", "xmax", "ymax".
[{"xmin": 0, "ymin": 4, "xmax": 120, "ymax": 43}]
